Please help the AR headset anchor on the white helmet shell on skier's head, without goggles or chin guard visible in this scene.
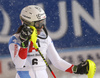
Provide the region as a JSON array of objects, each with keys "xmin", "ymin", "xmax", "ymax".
[{"xmin": 20, "ymin": 5, "xmax": 46, "ymax": 25}]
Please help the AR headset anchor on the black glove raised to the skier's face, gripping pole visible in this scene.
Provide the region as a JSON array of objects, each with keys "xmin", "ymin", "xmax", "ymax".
[{"xmin": 19, "ymin": 26, "xmax": 32, "ymax": 48}]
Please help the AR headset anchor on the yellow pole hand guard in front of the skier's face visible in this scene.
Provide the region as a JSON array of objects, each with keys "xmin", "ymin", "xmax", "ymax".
[{"xmin": 29, "ymin": 26, "xmax": 38, "ymax": 49}]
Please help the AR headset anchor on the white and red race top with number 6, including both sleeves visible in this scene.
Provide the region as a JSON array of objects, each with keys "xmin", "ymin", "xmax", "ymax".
[{"xmin": 9, "ymin": 34, "xmax": 73, "ymax": 73}]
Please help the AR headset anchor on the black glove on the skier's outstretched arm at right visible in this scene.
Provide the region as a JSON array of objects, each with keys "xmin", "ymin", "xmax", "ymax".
[{"xmin": 73, "ymin": 61, "xmax": 89, "ymax": 74}]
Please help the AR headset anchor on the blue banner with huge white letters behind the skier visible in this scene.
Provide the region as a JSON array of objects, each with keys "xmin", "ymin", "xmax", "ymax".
[{"xmin": 0, "ymin": 0, "xmax": 100, "ymax": 55}]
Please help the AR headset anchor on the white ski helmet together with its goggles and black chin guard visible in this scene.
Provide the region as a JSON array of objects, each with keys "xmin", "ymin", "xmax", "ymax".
[{"xmin": 20, "ymin": 5, "xmax": 48, "ymax": 39}]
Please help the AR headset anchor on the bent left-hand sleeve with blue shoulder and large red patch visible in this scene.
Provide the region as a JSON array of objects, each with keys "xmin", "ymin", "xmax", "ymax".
[{"xmin": 8, "ymin": 36, "xmax": 27, "ymax": 68}]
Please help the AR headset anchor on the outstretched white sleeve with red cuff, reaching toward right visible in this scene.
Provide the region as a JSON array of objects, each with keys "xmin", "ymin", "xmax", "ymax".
[{"xmin": 47, "ymin": 36, "xmax": 73, "ymax": 73}]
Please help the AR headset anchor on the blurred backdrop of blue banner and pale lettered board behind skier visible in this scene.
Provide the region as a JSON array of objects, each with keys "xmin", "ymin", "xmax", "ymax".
[{"xmin": 0, "ymin": 0, "xmax": 100, "ymax": 78}]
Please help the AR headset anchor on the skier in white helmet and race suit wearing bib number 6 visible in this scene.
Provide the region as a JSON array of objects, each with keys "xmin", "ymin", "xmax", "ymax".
[{"xmin": 9, "ymin": 5, "xmax": 89, "ymax": 78}]
